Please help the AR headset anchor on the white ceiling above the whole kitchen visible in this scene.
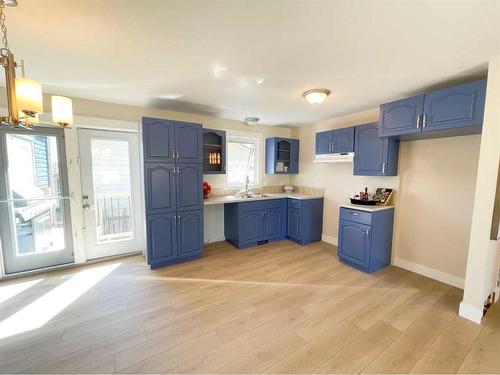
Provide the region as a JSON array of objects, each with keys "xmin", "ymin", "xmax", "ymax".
[{"xmin": 6, "ymin": 0, "xmax": 500, "ymax": 125}]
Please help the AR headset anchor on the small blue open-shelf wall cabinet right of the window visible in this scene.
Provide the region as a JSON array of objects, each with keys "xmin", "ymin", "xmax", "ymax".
[{"xmin": 266, "ymin": 137, "xmax": 299, "ymax": 174}]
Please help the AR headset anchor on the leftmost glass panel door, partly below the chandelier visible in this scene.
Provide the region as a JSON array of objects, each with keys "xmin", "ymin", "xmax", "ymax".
[{"xmin": 0, "ymin": 128, "xmax": 73, "ymax": 274}]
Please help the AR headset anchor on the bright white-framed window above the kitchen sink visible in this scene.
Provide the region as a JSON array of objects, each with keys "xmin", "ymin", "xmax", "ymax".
[{"xmin": 226, "ymin": 136, "xmax": 260, "ymax": 186}]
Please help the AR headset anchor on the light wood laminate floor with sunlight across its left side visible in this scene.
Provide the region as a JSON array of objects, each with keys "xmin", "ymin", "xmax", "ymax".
[{"xmin": 0, "ymin": 241, "xmax": 500, "ymax": 373}]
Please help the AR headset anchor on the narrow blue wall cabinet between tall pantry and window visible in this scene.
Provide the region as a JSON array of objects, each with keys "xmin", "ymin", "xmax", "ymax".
[{"xmin": 203, "ymin": 128, "xmax": 226, "ymax": 174}]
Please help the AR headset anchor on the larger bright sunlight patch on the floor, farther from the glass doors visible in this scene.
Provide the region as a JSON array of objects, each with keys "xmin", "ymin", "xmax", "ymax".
[{"xmin": 0, "ymin": 263, "xmax": 121, "ymax": 339}]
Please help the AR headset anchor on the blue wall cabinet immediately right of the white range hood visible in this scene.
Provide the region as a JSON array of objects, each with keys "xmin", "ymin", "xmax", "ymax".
[{"xmin": 354, "ymin": 123, "xmax": 399, "ymax": 176}]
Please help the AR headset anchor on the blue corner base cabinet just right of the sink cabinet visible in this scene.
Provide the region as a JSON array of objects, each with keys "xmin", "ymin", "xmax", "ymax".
[{"xmin": 287, "ymin": 198, "xmax": 323, "ymax": 245}]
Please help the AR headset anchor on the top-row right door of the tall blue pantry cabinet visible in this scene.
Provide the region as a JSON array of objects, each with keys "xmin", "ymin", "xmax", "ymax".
[{"xmin": 175, "ymin": 121, "xmax": 203, "ymax": 163}]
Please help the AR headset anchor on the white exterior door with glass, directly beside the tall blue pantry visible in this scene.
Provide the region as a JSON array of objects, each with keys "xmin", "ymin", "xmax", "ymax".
[{"xmin": 78, "ymin": 129, "xmax": 144, "ymax": 259}]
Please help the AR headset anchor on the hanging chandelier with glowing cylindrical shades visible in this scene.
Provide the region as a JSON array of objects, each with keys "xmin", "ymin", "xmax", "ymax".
[{"xmin": 0, "ymin": 0, "xmax": 73, "ymax": 128}]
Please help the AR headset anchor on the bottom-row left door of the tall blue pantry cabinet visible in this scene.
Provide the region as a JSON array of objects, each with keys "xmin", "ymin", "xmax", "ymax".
[{"xmin": 146, "ymin": 214, "xmax": 177, "ymax": 264}]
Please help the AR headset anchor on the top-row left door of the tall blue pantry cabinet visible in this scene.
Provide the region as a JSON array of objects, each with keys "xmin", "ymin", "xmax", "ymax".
[{"xmin": 142, "ymin": 117, "xmax": 175, "ymax": 163}]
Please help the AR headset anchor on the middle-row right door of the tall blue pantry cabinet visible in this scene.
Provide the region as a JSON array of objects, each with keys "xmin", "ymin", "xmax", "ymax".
[{"xmin": 176, "ymin": 164, "xmax": 203, "ymax": 211}]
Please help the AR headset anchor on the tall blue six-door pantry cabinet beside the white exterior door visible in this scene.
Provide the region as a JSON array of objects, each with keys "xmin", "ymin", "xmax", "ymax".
[{"xmin": 142, "ymin": 117, "xmax": 203, "ymax": 268}]
